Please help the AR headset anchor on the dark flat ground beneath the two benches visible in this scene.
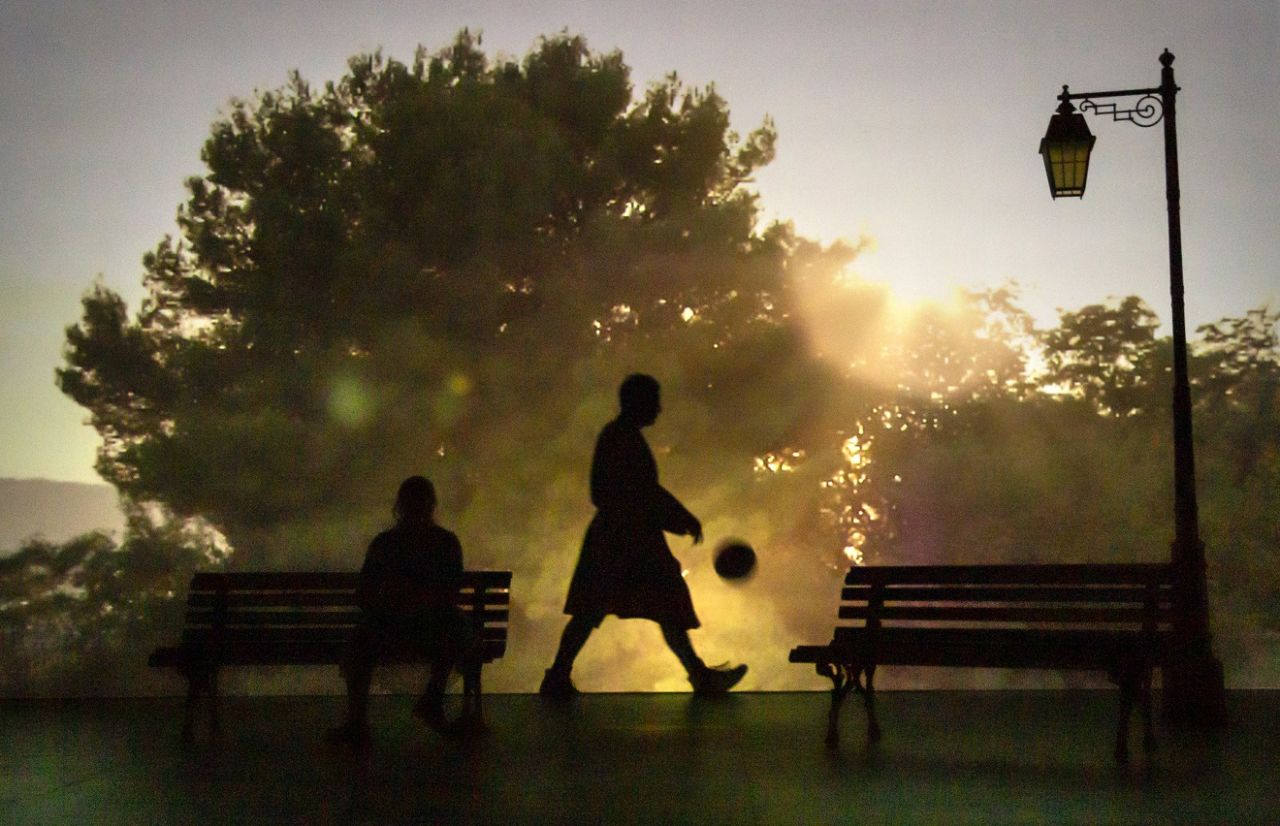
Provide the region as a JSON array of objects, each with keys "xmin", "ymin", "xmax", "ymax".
[{"xmin": 0, "ymin": 692, "xmax": 1280, "ymax": 826}]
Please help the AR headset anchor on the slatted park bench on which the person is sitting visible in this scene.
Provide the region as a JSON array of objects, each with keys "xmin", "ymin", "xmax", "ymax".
[{"xmin": 147, "ymin": 571, "xmax": 511, "ymax": 739}]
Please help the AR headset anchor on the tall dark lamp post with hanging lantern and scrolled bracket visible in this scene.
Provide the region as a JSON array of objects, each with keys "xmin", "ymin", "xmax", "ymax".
[{"xmin": 1039, "ymin": 49, "xmax": 1226, "ymax": 727}]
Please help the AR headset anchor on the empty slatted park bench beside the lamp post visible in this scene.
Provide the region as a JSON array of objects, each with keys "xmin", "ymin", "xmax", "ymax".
[{"xmin": 790, "ymin": 565, "xmax": 1174, "ymax": 762}]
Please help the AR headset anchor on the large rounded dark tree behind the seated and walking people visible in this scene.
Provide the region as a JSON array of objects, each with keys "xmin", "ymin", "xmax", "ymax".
[{"xmin": 59, "ymin": 32, "xmax": 839, "ymax": 561}]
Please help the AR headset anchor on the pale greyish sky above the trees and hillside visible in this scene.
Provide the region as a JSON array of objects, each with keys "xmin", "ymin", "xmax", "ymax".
[{"xmin": 0, "ymin": 0, "xmax": 1280, "ymax": 482}]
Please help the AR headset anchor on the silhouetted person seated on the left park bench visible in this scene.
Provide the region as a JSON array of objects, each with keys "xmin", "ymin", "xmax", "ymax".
[{"xmin": 329, "ymin": 476, "xmax": 480, "ymax": 745}]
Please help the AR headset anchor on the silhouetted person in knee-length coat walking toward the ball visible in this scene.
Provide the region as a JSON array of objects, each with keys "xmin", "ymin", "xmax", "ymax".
[{"xmin": 540, "ymin": 374, "xmax": 746, "ymax": 698}]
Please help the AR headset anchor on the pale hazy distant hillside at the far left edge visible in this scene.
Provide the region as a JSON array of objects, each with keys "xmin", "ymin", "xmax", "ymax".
[{"xmin": 0, "ymin": 479, "xmax": 124, "ymax": 556}]
